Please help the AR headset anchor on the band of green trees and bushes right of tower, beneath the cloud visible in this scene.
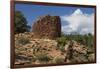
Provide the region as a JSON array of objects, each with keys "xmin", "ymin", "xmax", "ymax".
[{"xmin": 56, "ymin": 33, "xmax": 94, "ymax": 52}]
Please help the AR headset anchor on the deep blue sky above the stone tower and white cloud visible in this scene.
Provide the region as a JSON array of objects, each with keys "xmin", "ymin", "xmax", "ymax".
[{"xmin": 15, "ymin": 4, "xmax": 94, "ymax": 34}]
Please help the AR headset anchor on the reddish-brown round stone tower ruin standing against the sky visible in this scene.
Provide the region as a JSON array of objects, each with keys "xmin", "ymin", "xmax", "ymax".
[{"xmin": 32, "ymin": 15, "xmax": 61, "ymax": 39}]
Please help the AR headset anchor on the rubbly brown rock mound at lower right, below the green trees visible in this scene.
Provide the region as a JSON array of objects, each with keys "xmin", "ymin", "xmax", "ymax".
[{"xmin": 65, "ymin": 40, "xmax": 95, "ymax": 63}]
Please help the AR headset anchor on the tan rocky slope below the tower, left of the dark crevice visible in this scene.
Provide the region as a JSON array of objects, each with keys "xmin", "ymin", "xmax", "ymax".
[{"xmin": 15, "ymin": 33, "xmax": 64, "ymax": 65}]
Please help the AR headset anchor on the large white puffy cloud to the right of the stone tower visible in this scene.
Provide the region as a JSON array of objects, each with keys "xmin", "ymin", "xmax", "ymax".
[{"xmin": 61, "ymin": 9, "xmax": 94, "ymax": 34}]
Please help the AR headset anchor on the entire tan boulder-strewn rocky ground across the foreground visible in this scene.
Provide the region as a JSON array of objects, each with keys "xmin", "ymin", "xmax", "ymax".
[{"xmin": 15, "ymin": 32, "xmax": 95, "ymax": 65}]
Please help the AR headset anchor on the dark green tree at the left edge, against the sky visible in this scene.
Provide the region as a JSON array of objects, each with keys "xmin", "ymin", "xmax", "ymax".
[{"xmin": 14, "ymin": 11, "xmax": 30, "ymax": 33}]
